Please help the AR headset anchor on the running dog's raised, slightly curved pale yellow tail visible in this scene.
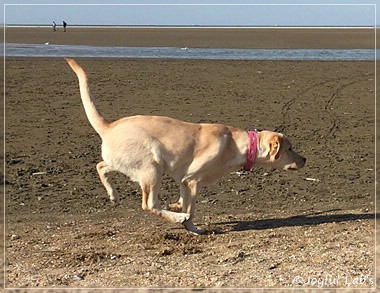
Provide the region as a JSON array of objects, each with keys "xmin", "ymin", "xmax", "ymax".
[{"xmin": 65, "ymin": 58, "xmax": 109, "ymax": 136}]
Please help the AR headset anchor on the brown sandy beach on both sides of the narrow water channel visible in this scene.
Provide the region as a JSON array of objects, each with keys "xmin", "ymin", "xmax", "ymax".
[{"xmin": 5, "ymin": 27, "xmax": 380, "ymax": 292}]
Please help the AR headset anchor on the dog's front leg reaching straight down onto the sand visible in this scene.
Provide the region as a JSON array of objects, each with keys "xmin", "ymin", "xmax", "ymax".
[{"xmin": 180, "ymin": 180, "xmax": 205, "ymax": 235}]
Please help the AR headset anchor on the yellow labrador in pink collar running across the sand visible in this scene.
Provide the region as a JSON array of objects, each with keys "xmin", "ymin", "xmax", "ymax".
[{"xmin": 66, "ymin": 59, "xmax": 306, "ymax": 234}]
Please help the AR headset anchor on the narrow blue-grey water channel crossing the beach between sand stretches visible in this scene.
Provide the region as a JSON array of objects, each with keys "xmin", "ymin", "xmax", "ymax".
[{"xmin": 1, "ymin": 43, "xmax": 379, "ymax": 61}]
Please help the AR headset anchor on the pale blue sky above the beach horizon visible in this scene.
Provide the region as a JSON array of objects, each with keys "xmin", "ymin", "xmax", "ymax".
[{"xmin": 1, "ymin": 0, "xmax": 380, "ymax": 26}]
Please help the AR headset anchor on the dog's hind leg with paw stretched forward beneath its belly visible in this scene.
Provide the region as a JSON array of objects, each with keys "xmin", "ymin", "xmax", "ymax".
[{"xmin": 140, "ymin": 166, "xmax": 190, "ymax": 224}]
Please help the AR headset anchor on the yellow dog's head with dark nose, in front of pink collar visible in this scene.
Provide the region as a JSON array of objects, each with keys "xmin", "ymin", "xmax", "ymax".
[{"xmin": 255, "ymin": 131, "xmax": 306, "ymax": 170}]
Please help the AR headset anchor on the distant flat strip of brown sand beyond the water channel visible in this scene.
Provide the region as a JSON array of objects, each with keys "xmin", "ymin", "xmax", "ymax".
[{"xmin": 5, "ymin": 27, "xmax": 375, "ymax": 49}]
